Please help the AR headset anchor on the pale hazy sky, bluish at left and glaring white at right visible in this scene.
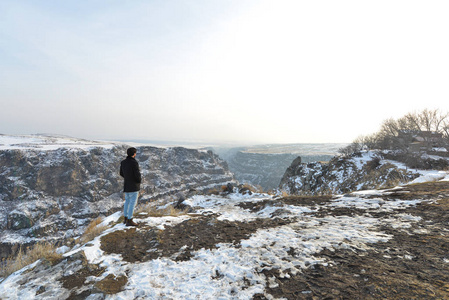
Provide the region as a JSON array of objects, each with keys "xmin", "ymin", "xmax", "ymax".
[{"xmin": 0, "ymin": 0, "xmax": 449, "ymax": 143}]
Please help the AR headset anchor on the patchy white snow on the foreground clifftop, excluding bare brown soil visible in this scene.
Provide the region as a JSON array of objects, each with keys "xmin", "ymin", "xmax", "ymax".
[{"xmin": 0, "ymin": 183, "xmax": 434, "ymax": 299}]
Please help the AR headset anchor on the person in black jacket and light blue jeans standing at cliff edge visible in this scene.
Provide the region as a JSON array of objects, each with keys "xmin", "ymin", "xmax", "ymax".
[{"xmin": 120, "ymin": 147, "xmax": 142, "ymax": 226}]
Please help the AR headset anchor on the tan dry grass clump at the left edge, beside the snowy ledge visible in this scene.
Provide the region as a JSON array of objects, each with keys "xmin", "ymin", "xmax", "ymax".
[{"xmin": 0, "ymin": 242, "xmax": 62, "ymax": 277}]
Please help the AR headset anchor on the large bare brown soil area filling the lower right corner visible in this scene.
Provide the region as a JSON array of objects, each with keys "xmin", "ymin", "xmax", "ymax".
[{"xmin": 254, "ymin": 182, "xmax": 449, "ymax": 299}]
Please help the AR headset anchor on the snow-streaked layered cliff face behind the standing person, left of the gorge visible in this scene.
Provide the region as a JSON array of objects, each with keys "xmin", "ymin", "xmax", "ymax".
[{"xmin": 0, "ymin": 145, "xmax": 234, "ymax": 257}]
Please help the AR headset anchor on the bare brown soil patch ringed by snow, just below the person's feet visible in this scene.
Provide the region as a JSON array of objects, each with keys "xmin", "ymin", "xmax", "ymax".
[{"xmin": 101, "ymin": 215, "xmax": 288, "ymax": 262}]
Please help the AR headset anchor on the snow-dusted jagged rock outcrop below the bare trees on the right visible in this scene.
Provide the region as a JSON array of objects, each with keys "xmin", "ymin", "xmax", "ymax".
[{"xmin": 279, "ymin": 152, "xmax": 419, "ymax": 195}]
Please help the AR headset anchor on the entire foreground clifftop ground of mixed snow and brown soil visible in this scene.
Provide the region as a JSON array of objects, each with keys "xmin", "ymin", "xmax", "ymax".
[{"xmin": 0, "ymin": 177, "xmax": 449, "ymax": 299}]
